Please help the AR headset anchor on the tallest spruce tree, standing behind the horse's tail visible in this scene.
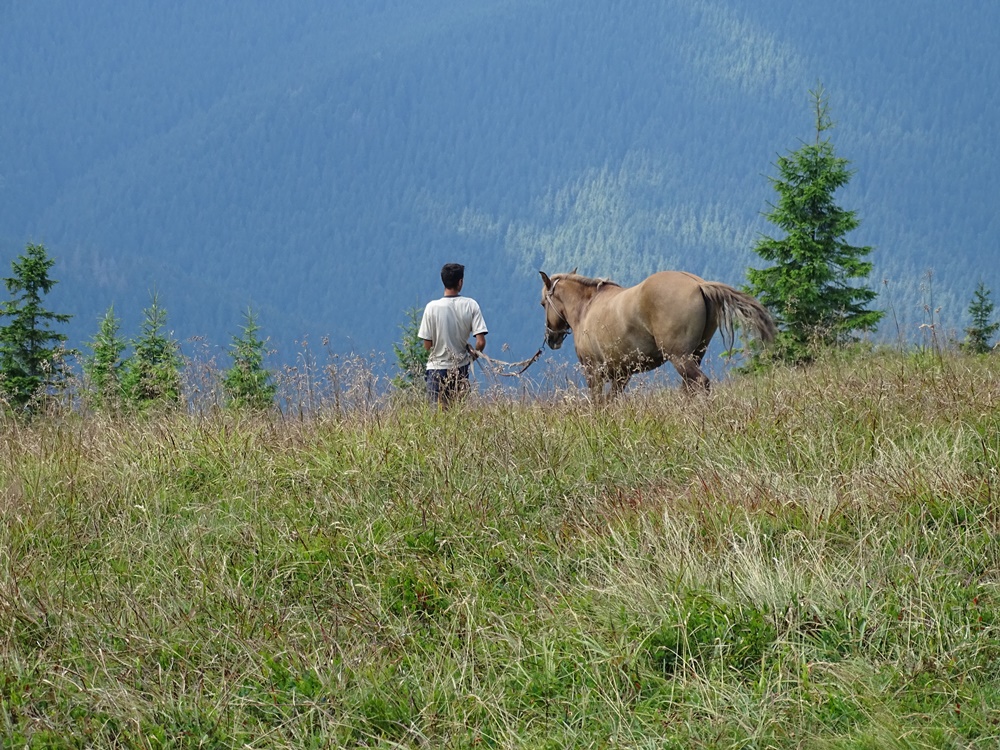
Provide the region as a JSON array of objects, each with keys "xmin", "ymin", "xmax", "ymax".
[{"xmin": 747, "ymin": 86, "xmax": 884, "ymax": 362}]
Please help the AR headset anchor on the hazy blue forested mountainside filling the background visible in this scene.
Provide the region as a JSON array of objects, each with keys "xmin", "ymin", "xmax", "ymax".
[{"xmin": 0, "ymin": 0, "xmax": 1000, "ymax": 374}]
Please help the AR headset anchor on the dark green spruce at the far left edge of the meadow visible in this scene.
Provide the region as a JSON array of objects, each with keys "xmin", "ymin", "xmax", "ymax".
[{"xmin": 0, "ymin": 244, "xmax": 73, "ymax": 410}]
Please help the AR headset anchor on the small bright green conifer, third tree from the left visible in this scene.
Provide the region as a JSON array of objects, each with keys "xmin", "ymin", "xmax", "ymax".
[{"xmin": 122, "ymin": 294, "xmax": 184, "ymax": 409}]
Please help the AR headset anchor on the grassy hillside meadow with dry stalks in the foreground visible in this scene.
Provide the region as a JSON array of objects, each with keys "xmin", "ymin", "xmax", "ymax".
[{"xmin": 0, "ymin": 354, "xmax": 1000, "ymax": 748}]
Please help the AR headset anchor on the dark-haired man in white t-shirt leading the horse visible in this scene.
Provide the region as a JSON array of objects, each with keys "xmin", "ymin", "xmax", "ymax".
[{"xmin": 417, "ymin": 263, "xmax": 488, "ymax": 409}]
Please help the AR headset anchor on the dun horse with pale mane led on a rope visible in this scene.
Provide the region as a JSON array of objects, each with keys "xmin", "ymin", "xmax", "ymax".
[{"xmin": 539, "ymin": 271, "xmax": 776, "ymax": 399}]
